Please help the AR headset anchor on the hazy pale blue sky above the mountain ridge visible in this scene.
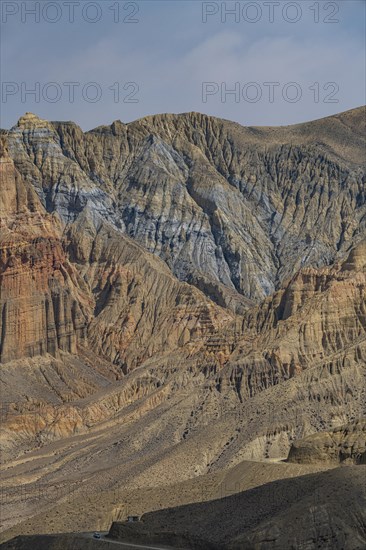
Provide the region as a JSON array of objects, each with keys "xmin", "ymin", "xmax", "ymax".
[{"xmin": 1, "ymin": 0, "xmax": 366, "ymax": 130}]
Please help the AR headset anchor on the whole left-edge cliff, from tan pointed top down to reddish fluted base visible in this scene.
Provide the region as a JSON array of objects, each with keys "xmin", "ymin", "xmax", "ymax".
[{"xmin": 0, "ymin": 136, "xmax": 86, "ymax": 362}]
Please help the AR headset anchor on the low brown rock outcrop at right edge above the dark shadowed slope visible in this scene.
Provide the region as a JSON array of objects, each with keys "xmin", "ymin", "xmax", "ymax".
[{"xmin": 288, "ymin": 419, "xmax": 366, "ymax": 464}]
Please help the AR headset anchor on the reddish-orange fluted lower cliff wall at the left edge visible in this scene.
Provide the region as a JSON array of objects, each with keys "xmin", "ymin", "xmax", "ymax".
[{"xmin": 0, "ymin": 237, "xmax": 86, "ymax": 362}]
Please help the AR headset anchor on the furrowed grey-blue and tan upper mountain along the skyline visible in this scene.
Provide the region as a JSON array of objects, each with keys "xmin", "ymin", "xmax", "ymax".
[{"xmin": 8, "ymin": 109, "xmax": 366, "ymax": 312}]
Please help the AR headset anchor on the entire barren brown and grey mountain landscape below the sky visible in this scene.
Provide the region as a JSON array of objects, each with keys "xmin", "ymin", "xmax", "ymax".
[{"xmin": 0, "ymin": 107, "xmax": 366, "ymax": 550}]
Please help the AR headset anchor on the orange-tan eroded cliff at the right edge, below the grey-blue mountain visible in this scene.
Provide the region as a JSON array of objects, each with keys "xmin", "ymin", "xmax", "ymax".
[{"xmin": 226, "ymin": 241, "xmax": 366, "ymax": 394}]
